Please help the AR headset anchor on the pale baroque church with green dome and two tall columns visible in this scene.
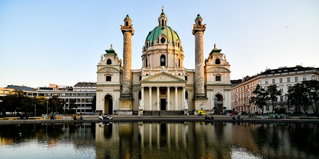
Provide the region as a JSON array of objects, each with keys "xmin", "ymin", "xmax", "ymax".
[{"xmin": 96, "ymin": 9, "xmax": 231, "ymax": 115}]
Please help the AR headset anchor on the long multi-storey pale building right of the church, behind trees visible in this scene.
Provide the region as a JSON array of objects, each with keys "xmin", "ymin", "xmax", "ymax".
[{"xmin": 232, "ymin": 65, "xmax": 319, "ymax": 113}]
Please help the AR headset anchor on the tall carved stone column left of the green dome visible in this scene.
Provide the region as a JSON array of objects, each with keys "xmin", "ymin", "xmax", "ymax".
[{"xmin": 119, "ymin": 15, "xmax": 134, "ymax": 114}]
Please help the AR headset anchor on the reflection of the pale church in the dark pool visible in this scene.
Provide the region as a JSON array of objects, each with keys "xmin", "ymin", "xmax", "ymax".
[{"xmin": 96, "ymin": 123, "xmax": 232, "ymax": 158}]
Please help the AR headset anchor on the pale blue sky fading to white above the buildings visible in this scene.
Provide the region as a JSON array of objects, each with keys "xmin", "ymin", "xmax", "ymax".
[{"xmin": 0, "ymin": 0, "xmax": 319, "ymax": 87}]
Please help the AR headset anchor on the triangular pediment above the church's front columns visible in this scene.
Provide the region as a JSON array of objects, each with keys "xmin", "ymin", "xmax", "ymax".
[{"xmin": 141, "ymin": 72, "xmax": 185, "ymax": 83}]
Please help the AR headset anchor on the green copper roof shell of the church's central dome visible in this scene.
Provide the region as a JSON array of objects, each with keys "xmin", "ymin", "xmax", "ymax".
[{"xmin": 146, "ymin": 26, "xmax": 180, "ymax": 45}]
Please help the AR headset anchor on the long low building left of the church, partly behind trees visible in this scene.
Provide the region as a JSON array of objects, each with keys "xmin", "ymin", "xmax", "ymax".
[{"xmin": 0, "ymin": 82, "xmax": 96, "ymax": 114}]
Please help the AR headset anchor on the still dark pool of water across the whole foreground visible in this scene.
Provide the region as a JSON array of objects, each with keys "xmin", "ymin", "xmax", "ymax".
[{"xmin": 0, "ymin": 122, "xmax": 319, "ymax": 159}]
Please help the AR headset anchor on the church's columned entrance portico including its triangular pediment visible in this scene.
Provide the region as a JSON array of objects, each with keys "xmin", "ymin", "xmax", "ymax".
[{"xmin": 139, "ymin": 72, "xmax": 186, "ymax": 114}]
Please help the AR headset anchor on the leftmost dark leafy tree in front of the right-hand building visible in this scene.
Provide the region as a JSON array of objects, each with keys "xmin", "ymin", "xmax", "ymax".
[{"xmin": 249, "ymin": 84, "xmax": 268, "ymax": 112}]
